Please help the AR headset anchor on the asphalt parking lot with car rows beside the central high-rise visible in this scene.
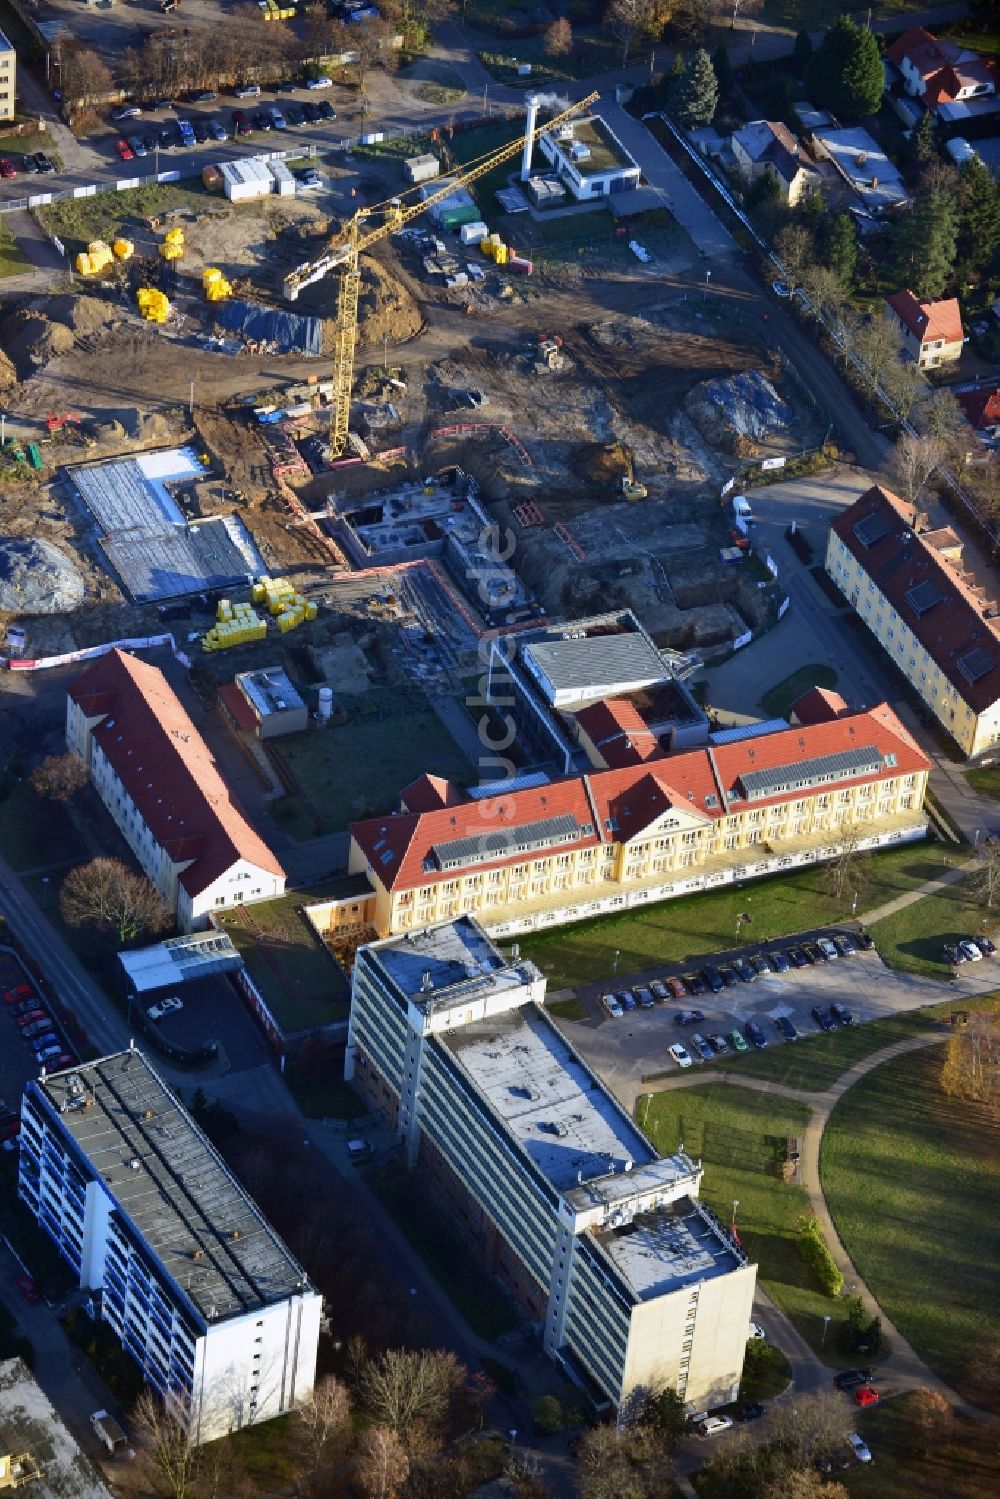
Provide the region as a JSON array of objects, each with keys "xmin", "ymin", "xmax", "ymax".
[{"xmin": 570, "ymin": 928, "xmax": 1000, "ymax": 1108}]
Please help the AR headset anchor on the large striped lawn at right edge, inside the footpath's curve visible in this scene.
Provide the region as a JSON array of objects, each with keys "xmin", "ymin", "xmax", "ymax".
[{"xmin": 820, "ymin": 1048, "xmax": 1000, "ymax": 1394}]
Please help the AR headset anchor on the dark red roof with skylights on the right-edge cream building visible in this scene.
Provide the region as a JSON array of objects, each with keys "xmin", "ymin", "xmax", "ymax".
[{"xmin": 832, "ymin": 484, "xmax": 1000, "ymax": 714}]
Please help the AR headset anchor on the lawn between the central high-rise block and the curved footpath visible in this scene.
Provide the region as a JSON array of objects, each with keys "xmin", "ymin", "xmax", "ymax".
[{"xmin": 636, "ymin": 1084, "xmax": 869, "ymax": 1366}]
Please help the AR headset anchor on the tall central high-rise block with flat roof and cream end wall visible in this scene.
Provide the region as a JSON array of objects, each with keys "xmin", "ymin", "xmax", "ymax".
[{"xmin": 346, "ymin": 916, "xmax": 756, "ymax": 1411}]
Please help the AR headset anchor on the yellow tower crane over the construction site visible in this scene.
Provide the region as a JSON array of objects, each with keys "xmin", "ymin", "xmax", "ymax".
[{"xmin": 285, "ymin": 93, "xmax": 600, "ymax": 457}]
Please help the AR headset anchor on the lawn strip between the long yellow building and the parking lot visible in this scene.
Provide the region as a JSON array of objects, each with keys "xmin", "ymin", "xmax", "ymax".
[{"xmin": 522, "ymin": 844, "xmax": 953, "ymax": 989}]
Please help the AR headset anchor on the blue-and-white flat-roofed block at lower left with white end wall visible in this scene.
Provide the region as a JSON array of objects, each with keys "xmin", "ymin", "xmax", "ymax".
[{"xmin": 18, "ymin": 1049, "xmax": 322, "ymax": 1444}]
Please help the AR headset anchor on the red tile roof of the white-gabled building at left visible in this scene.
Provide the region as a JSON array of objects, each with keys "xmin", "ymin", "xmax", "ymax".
[{"xmin": 69, "ymin": 651, "xmax": 285, "ymax": 896}]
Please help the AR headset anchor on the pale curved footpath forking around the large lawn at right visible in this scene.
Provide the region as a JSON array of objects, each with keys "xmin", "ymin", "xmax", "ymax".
[{"xmin": 650, "ymin": 1034, "xmax": 1000, "ymax": 1426}]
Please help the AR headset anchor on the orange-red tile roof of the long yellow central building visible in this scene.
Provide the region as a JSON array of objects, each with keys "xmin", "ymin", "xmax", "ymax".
[{"xmin": 351, "ymin": 703, "xmax": 930, "ymax": 890}]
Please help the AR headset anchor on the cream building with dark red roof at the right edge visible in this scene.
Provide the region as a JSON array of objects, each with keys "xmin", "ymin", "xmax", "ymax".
[{"xmin": 826, "ymin": 484, "xmax": 1000, "ymax": 755}]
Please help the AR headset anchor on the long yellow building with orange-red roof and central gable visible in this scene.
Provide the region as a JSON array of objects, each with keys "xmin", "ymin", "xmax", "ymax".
[{"xmin": 329, "ymin": 702, "xmax": 930, "ymax": 935}]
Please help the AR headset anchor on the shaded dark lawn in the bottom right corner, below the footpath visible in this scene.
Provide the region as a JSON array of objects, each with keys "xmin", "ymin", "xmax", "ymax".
[{"xmin": 837, "ymin": 1396, "xmax": 997, "ymax": 1499}]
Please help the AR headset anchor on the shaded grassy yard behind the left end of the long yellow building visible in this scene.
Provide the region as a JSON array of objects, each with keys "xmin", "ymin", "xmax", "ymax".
[{"xmin": 263, "ymin": 691, "xmax": 474, "ymax": 838}]
